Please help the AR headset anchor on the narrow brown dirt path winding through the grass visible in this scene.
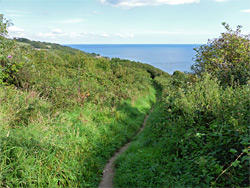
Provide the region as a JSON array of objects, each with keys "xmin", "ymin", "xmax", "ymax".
[{"xmin": 99, "ymin": 107, "xmax": 154, "ymax": 188}]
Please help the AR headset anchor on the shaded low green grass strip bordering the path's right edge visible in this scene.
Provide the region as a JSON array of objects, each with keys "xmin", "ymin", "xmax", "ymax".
[{"xmin": 114, "ymin": 89, "xmax": 162, "ymax": 187}]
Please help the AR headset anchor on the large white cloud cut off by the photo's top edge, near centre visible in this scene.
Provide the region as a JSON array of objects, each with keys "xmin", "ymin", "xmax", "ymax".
[{"xmin": 100, "ymin": 0, "xmax": 200, "ymax": 8}]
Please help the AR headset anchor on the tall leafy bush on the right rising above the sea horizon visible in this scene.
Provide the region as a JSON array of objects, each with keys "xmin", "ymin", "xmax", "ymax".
[{"xmin": 191, "ymin": 23, "xmax": 250, "ymax": 86}]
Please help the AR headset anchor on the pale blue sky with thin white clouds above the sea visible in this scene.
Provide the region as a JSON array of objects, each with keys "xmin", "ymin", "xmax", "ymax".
[{"xmin": 0, "ymin": 0, "xmax": 250, "ymax": 44}]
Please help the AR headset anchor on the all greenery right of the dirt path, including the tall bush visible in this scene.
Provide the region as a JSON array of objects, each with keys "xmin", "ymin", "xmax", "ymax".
[{"xmin": 115, "ymin": 23, "xmax": 250, "ymax": 187}]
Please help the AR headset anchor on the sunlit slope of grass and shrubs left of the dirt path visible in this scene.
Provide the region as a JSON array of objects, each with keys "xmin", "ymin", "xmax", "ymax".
[{"xmin": 0, "ymin": 41, "xmax": 163, "ymax": 187}]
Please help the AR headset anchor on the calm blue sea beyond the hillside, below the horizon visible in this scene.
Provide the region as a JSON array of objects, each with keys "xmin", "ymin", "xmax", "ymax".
[{"xmin": 67, "ymin": 44, "xmax": 200, "ymax": 74}]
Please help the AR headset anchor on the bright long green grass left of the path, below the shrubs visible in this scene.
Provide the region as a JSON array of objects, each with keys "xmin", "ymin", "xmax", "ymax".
[{"xmin": 0, "ymin": 87, "xmax": 155, "ymax": 187}]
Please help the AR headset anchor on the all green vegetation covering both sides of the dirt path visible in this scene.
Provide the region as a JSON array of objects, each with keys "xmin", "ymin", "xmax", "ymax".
[{"xmin": 0, "ymin": 15, "xmax": 250, "ymax": 187}]
